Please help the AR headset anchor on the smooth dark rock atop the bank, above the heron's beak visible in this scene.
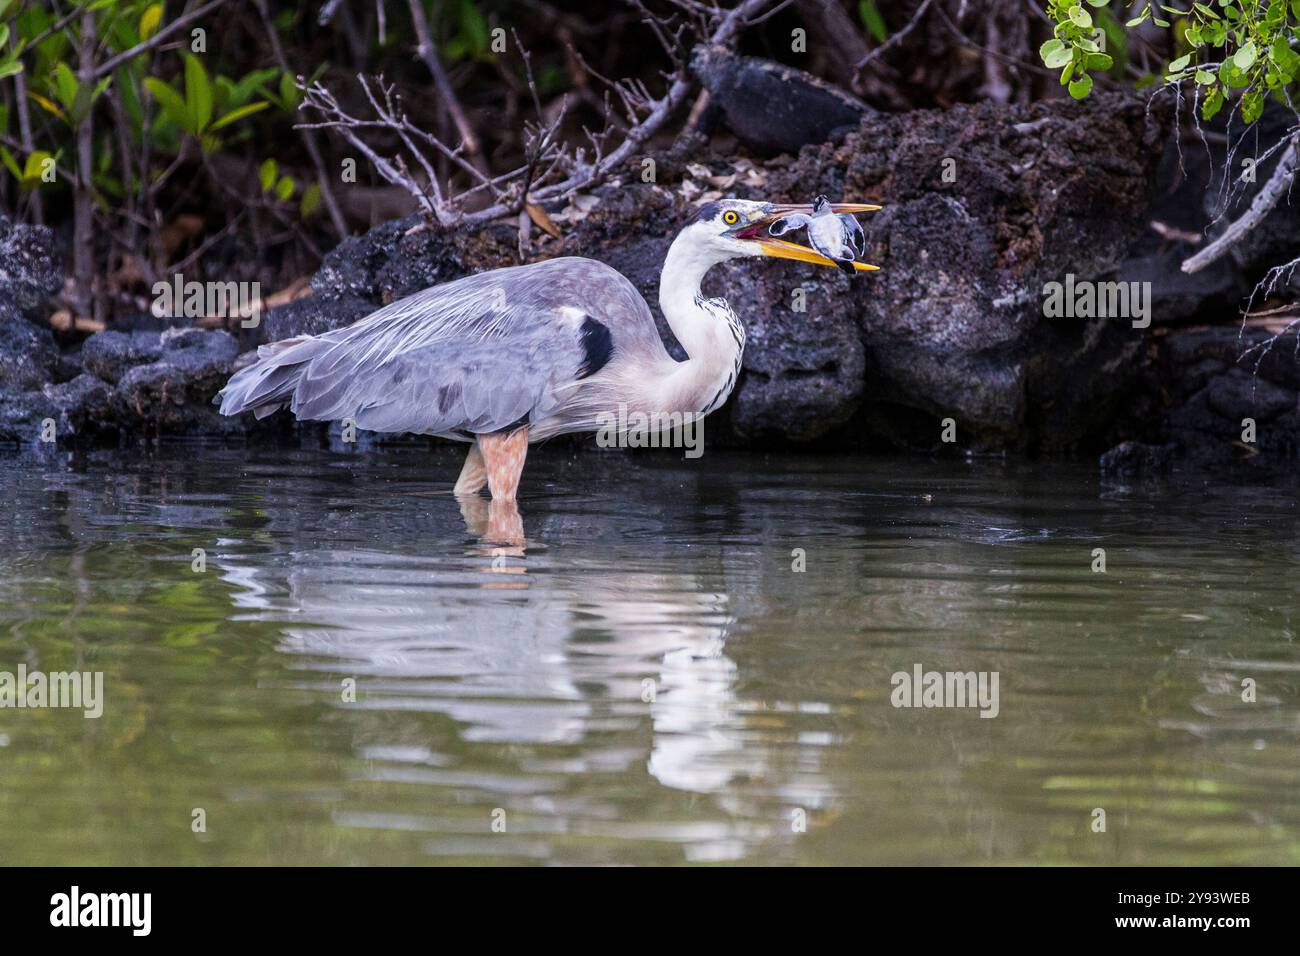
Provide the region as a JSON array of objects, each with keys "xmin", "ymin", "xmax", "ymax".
[{"xmin": 690, "ymin": 47, "xmax": 871, "ymax": 155}]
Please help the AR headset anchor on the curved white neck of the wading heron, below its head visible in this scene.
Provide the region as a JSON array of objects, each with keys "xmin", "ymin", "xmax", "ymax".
[{"xmin": 659, "ymin": 233, "xmax": 745, "ymax": 411}]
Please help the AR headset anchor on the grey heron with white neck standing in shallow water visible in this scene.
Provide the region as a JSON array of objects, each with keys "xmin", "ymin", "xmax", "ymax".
[{"xmin": 215, "ymin": 199, "xmax": 880, "ymax": 501}]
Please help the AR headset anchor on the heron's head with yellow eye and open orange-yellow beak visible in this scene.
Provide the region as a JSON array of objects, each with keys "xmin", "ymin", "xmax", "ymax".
[{"xmin": 683, "ymin": 196, "xmax": 880, "ymax": 272}]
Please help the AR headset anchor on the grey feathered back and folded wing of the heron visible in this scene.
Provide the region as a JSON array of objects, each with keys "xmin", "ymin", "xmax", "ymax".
[{"xmin": 217, "ymin": 258, "xmax": 671, "ymax": 437}]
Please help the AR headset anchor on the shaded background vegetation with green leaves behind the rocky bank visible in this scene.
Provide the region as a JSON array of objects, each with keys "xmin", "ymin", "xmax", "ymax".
[{"xmin": 0, "ymin": 0, "xmax": 1196, "ymax": 330}]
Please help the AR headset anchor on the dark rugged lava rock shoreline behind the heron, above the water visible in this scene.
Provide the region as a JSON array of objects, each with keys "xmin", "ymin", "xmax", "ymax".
[{"xmin": 0, "ymin": 94, "xmax": 1300, "ymax": 472}]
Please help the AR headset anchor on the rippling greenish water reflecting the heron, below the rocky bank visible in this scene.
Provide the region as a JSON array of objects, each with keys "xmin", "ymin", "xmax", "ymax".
[{"xmin": 0, "ymin": 445, "xmax": 1300, "ymax": 865}]
